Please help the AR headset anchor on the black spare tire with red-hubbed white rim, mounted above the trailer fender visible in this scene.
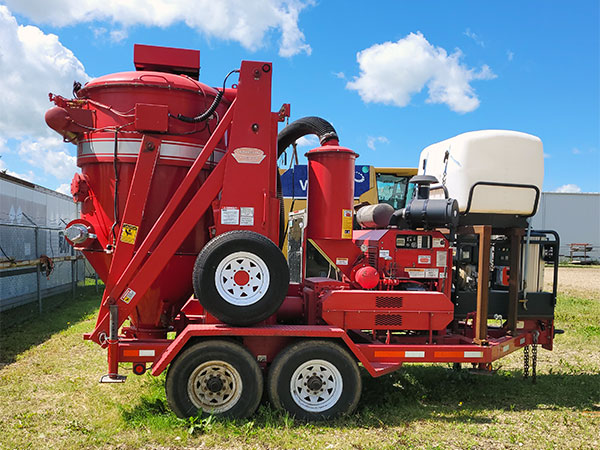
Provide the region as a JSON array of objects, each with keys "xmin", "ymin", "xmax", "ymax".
[{"xmin": 193, "ymin": 230, "xmax": 290, "ymax": 326}]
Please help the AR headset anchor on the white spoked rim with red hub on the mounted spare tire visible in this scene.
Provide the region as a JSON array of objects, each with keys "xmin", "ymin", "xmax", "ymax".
[{"xmin": 215, "ymin": 252, "xmax": 270, "ymax": 306}]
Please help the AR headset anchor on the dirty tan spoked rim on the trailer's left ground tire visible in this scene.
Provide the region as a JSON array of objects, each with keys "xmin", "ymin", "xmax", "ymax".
[{"xmin": 188, "ymin": 361, "xmax": 242, "ymax": 414}]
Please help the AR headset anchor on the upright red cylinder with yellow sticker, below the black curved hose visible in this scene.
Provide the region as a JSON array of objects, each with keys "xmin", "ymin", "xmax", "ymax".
[{"xmin": 306, "ymin": 145, "xmax": 358, "ymax": 239}]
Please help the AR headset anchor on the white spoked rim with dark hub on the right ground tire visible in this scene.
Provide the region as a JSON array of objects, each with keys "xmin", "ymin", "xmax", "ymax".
[{"xmin": 290, "ymin": 359, "xmax": 344, "ymax": 412}]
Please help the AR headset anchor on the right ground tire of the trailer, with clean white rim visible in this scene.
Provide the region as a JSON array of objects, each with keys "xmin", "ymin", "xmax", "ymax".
[{"xmin": 267, "ymin": 340, "xmax": 362, "ymax": 421}]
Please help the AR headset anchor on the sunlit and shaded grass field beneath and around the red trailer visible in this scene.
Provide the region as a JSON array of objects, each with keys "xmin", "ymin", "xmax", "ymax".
[{"xmin": 0, "ymin": 269, "xmax": 600, "ymax": 449}]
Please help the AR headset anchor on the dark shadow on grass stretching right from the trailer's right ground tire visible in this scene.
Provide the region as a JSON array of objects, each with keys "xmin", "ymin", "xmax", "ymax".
[{"xmin": 359, "ymin": 366, "xmax": 600, "ymax": 424}]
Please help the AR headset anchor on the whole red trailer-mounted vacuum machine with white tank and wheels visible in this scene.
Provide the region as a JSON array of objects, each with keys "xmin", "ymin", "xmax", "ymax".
[{"xmin": 46, "ymin": 45, "xmax": 558, "ymax": 420}]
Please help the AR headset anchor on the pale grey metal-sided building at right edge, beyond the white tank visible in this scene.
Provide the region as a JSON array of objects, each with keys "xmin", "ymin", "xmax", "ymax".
[{"xmin": 532, "ymin": 192, "xmax": 600, "ymax": 260}]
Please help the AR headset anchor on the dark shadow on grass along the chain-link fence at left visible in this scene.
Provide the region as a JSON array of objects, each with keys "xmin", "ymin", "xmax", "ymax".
[{"xmin": 0, "ymin": 286, "xmax": 102, "ymax": 365}]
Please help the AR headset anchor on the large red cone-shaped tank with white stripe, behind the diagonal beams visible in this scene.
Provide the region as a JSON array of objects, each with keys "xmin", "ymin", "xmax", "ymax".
[{"xmin": 69, "ymin": 71, "xmax": 231, "ymax": 337}]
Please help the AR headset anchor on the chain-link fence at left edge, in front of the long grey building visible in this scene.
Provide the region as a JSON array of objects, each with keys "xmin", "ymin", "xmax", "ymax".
[{"xmin": 0, "ymin": 221, "xmax": 86, "ymax": 314}]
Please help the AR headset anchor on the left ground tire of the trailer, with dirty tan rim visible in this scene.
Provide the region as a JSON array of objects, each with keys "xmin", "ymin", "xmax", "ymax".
[{"xmin": 165, "ymin": 340, "xmax": 263, "ymax": 418}]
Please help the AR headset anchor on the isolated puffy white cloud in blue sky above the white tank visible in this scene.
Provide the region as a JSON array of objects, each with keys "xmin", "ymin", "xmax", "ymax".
[{"xmin": 346, "ymin": 33, "xmax": 496, "ymax": 113}]
